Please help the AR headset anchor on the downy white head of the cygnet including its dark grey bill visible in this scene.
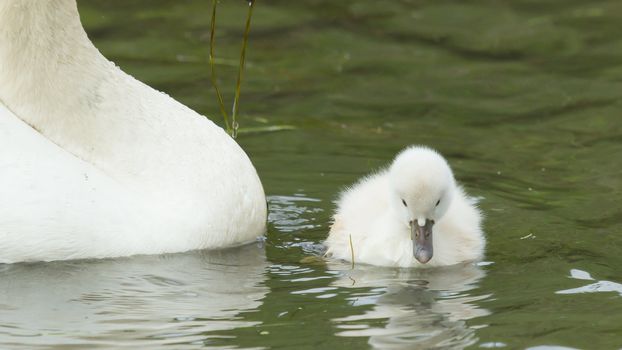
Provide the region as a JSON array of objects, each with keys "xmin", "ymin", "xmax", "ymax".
[{"xmin": 389, "ymin": 146, "xmax": 456, "ymax": 264}]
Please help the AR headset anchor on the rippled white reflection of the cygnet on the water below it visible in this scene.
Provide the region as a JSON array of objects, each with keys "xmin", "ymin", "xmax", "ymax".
[{"xmin": 334, "ymin": 264, "xmax": 488, "ymax": 349}]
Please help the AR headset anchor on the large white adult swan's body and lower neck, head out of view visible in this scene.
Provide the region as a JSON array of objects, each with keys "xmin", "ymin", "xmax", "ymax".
[{"xmin": 0, "ymin": 0, "xmax": 266, "ymax": 263}]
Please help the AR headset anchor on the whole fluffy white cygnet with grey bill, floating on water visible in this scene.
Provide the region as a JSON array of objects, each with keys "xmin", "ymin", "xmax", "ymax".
[{"xmin": 325, "ymin": 146, "xmax": 486, "ymax": 267}]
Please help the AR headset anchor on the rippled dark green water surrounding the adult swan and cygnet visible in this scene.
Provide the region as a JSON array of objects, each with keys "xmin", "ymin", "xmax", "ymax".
[{"xmin": 0, "ymin": 0, "xmax": 622, "ymax": 349}]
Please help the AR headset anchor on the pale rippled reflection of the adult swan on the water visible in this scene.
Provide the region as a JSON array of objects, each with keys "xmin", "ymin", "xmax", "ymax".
[{"xmin": 0, "ymin": 245, "xmax": 267, "ymax": 348}]
